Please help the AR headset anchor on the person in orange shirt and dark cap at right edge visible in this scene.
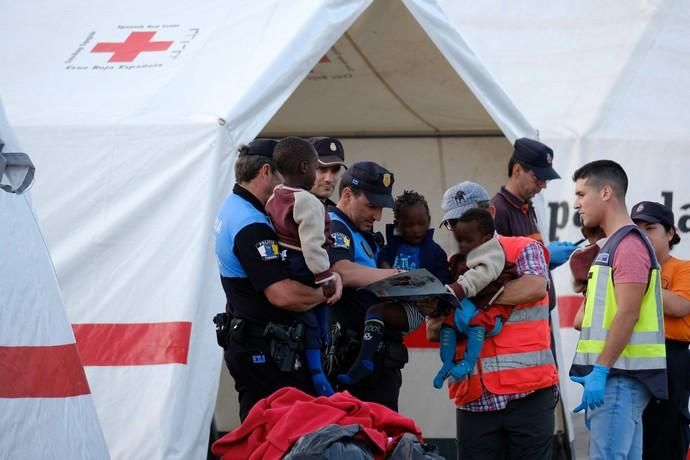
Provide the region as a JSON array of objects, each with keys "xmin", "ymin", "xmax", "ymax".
[{"xmin": 630, "ymin": 201, "xmax": 690, "ymax": 459}]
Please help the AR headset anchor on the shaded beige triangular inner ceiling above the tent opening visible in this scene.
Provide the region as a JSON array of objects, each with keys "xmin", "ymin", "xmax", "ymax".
[{"xmin": 262, "ymin": 1, "xmax": 500, "ymax": 137}]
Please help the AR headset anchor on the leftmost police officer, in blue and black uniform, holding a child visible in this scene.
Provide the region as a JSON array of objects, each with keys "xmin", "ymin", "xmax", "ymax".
[{"xmin": 214, "ymin": 139, "xmax": 342, "ymax": 420}]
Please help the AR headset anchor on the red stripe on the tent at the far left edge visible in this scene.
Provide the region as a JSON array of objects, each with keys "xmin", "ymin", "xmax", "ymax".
[{"xmin": 0, "ymin": 343, "xmax": 90, "ymax": 398}]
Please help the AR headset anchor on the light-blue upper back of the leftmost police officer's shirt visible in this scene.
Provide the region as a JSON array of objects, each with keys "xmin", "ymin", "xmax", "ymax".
[{"xmin": 214, "ymin": 193, "xmax": 278, "ymax": 278}]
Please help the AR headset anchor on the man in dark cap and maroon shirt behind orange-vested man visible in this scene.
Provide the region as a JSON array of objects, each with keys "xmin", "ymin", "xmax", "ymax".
[{"xmin": 491, "ymin": 137, "xmax": 577, "ymax": 309}]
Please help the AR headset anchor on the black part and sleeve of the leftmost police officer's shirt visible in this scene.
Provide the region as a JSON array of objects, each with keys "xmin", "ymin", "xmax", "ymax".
[{"xmin": 219, "ymin": 184, "xmax": 292, "ymax": 324}]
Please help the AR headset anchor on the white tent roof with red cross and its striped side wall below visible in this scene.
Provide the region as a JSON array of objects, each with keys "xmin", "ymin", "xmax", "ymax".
[{"xmin": 0, "ymin": 0, "xmax": 369, "ymax": 459}]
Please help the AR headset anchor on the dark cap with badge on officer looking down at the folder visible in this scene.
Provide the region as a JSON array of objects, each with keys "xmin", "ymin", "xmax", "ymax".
[{"xmin": 341, "ymin": 161, "xmax": 395, "ymax": 208}]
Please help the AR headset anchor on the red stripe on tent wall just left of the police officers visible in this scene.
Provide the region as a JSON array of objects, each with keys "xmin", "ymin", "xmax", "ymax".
[{"xmin": 72, "ymin": 321, "xmax": 192, "ymax": 366}]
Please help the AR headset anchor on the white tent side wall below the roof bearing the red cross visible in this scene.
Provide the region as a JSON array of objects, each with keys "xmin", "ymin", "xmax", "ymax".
[{"xmin": 14, "ymin": 124, "xmax": 227, "ymax": 458}]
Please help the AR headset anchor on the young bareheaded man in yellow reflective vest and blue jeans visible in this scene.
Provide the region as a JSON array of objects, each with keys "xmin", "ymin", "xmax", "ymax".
[{"xmin": 570, "ymin": 160, "xmax": 667, "ymax": 459}]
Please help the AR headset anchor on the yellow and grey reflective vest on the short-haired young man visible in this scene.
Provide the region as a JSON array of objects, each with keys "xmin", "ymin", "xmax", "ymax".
[{"xmin": 570, "ymin": 225, "xmax": 668, "ymax": 399}]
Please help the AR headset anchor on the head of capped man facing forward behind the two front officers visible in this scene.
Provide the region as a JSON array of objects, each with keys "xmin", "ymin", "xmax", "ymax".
[{"xmin": 309, "ymin": 137, "xmax": 347, "ymax": 206}]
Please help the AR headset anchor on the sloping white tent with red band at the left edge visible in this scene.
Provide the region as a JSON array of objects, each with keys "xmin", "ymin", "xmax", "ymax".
[{"xmin": 0, "ymin": 102, "xmax": 109, "ymax": 459}]
